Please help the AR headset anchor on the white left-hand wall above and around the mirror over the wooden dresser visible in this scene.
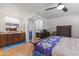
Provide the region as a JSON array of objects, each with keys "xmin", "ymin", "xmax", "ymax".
[{"xmin": 0, "ymin": 3, "xmax": 31, "ymax": 32}]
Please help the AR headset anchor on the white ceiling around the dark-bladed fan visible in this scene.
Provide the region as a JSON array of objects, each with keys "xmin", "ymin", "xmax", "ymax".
[{"xmin": 0, "ymin": 3, "xmax": 79, "ymax": 19}]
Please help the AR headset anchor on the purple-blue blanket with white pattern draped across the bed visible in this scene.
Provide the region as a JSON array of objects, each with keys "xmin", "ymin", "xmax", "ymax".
[{"xmin": 34, "ymin": 36, "xmax": 61, "ymax": 56}]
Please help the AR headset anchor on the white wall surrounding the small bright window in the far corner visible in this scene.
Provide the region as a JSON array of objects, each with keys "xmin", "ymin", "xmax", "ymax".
[{"xmin": 28, "ymin": 15, "xmax": 47, "ymax": 38}]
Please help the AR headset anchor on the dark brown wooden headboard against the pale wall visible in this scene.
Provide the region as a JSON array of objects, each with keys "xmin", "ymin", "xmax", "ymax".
[{"xmin": 56, "ymin": 25, "xmax": 72, "ymax": 37}]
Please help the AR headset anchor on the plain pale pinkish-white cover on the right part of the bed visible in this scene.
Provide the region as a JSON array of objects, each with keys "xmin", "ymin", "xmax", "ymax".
[{"xmin": 51, "ymin": 37, "xmax": 79, "ymax": 56}]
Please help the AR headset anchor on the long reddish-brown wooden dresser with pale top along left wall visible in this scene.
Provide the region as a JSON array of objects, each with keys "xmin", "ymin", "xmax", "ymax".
[{"xmin": 0, "ymin": 32, "xmax": 25, "ymax": 47}]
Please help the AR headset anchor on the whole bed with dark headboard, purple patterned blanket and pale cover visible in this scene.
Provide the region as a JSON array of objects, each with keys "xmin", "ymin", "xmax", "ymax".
[{"xmin": 35, "ymin": 25, "xmax": 79, "ymax": 56}]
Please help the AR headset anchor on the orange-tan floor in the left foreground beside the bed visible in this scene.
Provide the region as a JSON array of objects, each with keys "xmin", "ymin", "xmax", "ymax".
[{"xmin": 0, "ymin": 43, "xmax": 33, "ymax": 56}]
